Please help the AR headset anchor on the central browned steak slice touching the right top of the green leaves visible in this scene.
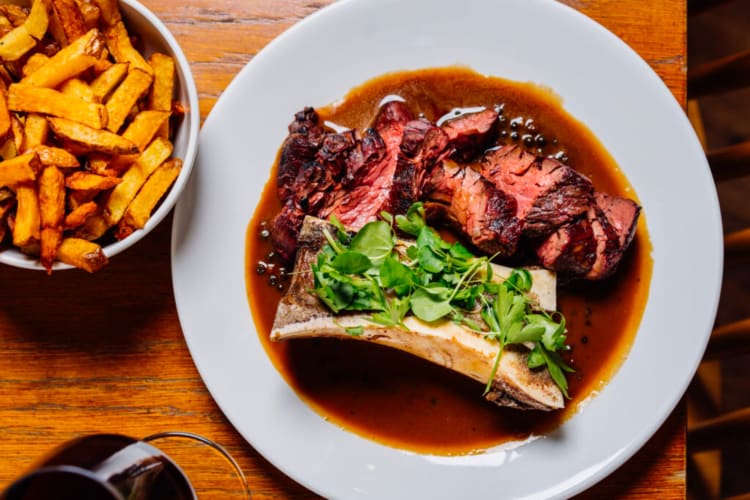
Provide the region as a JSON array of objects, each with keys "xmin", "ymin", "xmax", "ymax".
[{"xmin": 423, "ymin": 161, "xmax": 522, "ymax": 257}]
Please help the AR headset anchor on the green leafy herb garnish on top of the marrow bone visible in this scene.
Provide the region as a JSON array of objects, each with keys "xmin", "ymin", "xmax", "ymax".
[{"xmin": 311, "ymin": 203, "xmax": 573, "ymax": 397}]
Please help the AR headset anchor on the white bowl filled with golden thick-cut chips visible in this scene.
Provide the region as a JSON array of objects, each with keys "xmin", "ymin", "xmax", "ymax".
[{"xmin": 0, "ymin": 0, "xmax": 200, "ymax": 273}]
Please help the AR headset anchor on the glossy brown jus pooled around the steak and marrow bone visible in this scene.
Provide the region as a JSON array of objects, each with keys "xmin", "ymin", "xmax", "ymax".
[{"xmin": 246, "ymin": 67, "xmax": 653, "ymax": 455}]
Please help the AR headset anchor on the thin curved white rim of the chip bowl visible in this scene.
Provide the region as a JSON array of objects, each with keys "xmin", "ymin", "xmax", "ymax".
[{"xmin": 0, "ymin": 0, "xmax": 200, "ymax": 271}]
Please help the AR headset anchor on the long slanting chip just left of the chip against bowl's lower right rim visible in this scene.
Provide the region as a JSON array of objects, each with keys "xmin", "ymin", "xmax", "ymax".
[{"xmin": 104, "ymin": 137, "xmax": 172, "ymax": 226}]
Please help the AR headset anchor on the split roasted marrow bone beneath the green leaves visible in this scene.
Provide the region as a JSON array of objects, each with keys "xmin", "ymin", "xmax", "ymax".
[{"xmin": 271, "ymin": 216, "xmax": 564, "ymax": 411}]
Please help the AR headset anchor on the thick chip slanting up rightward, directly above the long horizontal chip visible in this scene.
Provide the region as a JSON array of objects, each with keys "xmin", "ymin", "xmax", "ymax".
[{"xmin": 21, "ymin": 29, "xmax": 104, "ymax": 88}]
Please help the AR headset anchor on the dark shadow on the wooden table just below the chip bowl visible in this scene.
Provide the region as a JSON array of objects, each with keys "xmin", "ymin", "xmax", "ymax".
[{"xmin": 0, "ymin": 219, "xmax": 179, "ymax": 353}]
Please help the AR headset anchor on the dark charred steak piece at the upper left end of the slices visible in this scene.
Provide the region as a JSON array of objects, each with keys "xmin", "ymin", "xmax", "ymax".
[{"xmin": 276, "ymin": 107, "xmax": 326, "ymax": 203}]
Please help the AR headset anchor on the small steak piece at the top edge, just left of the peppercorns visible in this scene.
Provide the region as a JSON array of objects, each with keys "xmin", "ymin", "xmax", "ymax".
[{"xmin": 441, "ymin": 109, "xmax": 498, "ymax": 162}]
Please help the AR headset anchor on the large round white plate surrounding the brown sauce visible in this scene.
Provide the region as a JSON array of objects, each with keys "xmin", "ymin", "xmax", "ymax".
[{"xmin": 172, "ymin": 0, "xmax": 722, "ymax": 499}]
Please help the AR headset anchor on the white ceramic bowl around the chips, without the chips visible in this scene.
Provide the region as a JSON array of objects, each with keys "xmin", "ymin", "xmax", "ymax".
[{"xmin": 0, "ymin": 0, "xmax": 200, "ymax": 270}]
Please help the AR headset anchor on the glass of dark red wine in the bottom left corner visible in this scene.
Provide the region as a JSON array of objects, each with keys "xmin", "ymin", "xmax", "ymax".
[{"xmin": 0, "ymin": 431, "xmax": 250, "ymax": 500}]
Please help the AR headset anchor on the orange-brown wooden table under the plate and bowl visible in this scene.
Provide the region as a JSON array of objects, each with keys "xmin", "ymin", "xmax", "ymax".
[{"xmin": 0, "ymin": 0, "xmax": 686, "ymax": 499}]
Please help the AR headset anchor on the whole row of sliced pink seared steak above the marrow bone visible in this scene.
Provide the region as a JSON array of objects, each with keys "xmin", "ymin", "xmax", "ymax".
[{"xmin": 270, "ymin": 101, "xmax": 640, "ymax": 279}]
